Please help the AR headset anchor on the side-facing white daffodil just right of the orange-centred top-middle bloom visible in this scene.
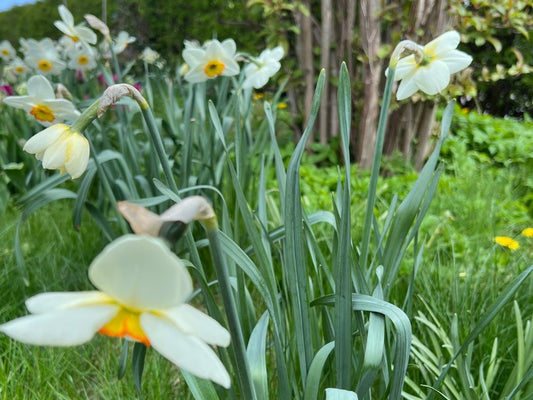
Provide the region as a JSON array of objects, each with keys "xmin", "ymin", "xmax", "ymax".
[{"xmin": 242, "ymin": 46, "xmax": 284, "ymax": 89}]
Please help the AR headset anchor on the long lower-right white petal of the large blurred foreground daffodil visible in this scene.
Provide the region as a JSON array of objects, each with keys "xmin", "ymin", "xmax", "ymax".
[{"xmin": 141, "ymin": 313, "xmax": 231, "ymax": 388}]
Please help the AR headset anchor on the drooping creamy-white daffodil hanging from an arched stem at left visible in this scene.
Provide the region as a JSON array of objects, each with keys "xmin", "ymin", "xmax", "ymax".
[{"xmin": 23, "ymin": 124, "xmax": 90, "ymax": 179}]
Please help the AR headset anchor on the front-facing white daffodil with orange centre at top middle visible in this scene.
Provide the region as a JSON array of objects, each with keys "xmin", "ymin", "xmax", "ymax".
[{"xmin": 183, "ymin": 39, "xmax": 239, "ymax": 83}]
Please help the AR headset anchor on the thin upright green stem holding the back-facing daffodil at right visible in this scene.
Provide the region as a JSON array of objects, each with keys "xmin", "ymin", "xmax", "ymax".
[{"xmin": 359, "ymin": 66, "xmax": 394, "ymax": 272}]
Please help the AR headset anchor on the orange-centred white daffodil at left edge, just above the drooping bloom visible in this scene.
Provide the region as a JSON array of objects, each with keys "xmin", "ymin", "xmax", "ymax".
[{"xmin": 4, "ymin": 75, "xmax": 80, "ymax": 126}]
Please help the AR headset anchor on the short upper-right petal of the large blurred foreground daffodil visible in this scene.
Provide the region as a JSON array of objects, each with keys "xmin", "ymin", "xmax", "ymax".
[{"xmin": 162, "ymin": 304, "xmax": 231, "ymax": 347}]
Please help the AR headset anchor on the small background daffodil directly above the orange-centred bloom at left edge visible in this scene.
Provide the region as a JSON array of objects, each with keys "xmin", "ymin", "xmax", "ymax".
[{"xmin": 24, "ymin": 38, "xmax": 67, "ymax": 75}]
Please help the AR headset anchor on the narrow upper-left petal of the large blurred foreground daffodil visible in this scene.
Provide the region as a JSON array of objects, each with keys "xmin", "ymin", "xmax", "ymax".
[{"xmin": 26, "ymin": 290, "xmax": 110, "ymax": 314}]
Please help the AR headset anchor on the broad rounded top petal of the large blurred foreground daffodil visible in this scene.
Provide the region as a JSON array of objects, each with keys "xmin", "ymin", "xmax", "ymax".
[{"xmin": 89, "ymin": 235, "xmax": 192, "ymax": 310}]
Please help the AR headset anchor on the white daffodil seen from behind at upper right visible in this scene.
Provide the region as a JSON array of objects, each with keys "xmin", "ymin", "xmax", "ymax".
[{"xmin": 394, "ymin": 31, "xmax": 472, "ymax": 100}]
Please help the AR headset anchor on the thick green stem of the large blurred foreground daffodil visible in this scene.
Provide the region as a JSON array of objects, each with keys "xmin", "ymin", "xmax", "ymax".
[{"xmin": 204, "ymin": 222, "xmax": 257, "ymax": 400}]
